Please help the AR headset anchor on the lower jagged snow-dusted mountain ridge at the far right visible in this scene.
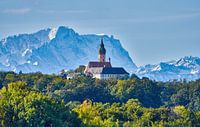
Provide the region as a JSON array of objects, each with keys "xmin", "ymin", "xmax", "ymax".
[{"xmin": 136, "ymin": 56, "xmax": 200, "ymax": 81}]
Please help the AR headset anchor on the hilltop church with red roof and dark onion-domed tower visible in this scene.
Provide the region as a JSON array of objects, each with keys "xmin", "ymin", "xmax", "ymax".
[{"xmin": 84, "ymin": 39, "xmax": 129, "ymax": 79}]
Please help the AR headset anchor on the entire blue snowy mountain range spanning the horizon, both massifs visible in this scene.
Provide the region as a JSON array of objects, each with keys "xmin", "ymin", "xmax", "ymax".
[{"xmin": 0, "ymin": 26, "xmax": 200, "ymax": 81}]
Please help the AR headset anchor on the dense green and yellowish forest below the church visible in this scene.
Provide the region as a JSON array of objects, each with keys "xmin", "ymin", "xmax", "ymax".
[{"xmin": 0, "ymin": 72, "xmax": 200, "ymax": 127}]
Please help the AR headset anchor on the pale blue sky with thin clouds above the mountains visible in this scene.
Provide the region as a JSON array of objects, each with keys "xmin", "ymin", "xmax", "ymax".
[{"xmin": 0, "ymin": 0, "xmax": 200, "ymax": 66}]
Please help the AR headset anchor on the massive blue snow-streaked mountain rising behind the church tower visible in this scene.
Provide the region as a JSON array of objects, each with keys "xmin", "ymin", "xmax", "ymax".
[{"xmin": 0, "ymin": 26, "xmax": 137, "ymax": 73}]
